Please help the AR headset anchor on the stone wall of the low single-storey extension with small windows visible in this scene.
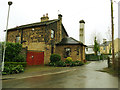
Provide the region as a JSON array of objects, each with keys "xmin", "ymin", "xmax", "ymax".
[{"xmin": 55, "ymin": 45, "xmax": 85, "ymax": 61}]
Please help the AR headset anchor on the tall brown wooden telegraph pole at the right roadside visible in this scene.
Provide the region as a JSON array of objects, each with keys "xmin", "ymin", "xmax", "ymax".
[{"xmin": 111, "ymin": 0, "xmax": 115, "ymax": 69}]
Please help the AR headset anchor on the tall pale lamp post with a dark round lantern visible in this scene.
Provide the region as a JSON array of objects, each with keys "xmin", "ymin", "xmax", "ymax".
[{"xmin": 2, "ymin": 1, "xmax": 12, "ymax": 71}]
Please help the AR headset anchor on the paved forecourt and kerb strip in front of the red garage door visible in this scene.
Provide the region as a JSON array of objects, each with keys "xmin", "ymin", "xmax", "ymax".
[{"xmin": 0, "ymin": 66, "xmax": 76, "ymax": 80}]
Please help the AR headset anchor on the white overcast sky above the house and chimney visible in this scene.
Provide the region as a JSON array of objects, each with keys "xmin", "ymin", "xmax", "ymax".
[{"xmin": 0, "ymin": 0, "xmax": 119, "ymax": 45}]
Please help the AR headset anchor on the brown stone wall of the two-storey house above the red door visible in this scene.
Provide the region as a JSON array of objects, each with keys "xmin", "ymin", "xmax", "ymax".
[{"xmin": 7, "ymin": 17, "xmax": 67, "ymax": 64}]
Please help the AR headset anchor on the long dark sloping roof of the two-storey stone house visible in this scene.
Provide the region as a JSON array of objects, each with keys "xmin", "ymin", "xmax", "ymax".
[{"xmin": 8, "ymin": 19, "xmax": 58, "ymax": 30}]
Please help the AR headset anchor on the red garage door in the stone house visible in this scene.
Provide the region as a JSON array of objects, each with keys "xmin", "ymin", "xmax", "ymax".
[{"xmin": 27, "ymin": 51, "xmax": 44, "ymax": 65}]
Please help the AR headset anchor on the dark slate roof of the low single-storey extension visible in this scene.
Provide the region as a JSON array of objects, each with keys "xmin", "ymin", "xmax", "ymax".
[{"xmin": 56, "ymin": 37, "xmax": 86, "ymax": 46}]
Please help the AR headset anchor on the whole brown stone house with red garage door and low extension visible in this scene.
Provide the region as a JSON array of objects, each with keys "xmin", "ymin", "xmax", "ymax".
[{"xmin": 7, "ymin": 14, "xmax": 85, "ymax": 65}]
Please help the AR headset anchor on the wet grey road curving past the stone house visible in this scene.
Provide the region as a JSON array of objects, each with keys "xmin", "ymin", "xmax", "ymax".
[{"xmin": 2, "ymin": 61, "xmax": 118, "ymax": 88}]
